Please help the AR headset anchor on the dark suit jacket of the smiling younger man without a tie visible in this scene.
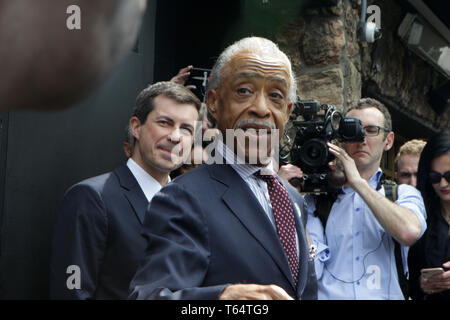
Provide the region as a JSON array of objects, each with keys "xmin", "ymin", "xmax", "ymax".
[{"xmin": 50, "ymin": 165, "xmax": 148, "ymax": 299}]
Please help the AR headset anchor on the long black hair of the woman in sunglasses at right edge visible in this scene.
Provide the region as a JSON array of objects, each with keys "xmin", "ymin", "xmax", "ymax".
[{"xmin": 416, "ymin": 131, "xmax": 450, "ymax": 219}]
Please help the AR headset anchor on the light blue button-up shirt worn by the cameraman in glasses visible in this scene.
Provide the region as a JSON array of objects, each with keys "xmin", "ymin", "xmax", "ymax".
[{"xmin": 305, "ymin": 169, "xmax": 426, "ymax": 300}]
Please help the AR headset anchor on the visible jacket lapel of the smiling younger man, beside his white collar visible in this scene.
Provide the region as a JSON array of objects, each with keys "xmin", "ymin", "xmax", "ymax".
[{"xmin": 114, "ymin": 165, "xmax": 148, "ymax": 224}]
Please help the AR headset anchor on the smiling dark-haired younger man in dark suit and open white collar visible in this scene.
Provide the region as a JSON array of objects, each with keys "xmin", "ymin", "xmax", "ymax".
[{"xmin": 50, "ymin": 82, "xmax": 200, "ymax": 299}]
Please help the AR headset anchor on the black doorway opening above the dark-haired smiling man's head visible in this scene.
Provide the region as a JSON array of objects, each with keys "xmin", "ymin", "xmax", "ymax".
[{"xmin": 155, "ymin": 0, "xmax": 240, "ymax": 90}]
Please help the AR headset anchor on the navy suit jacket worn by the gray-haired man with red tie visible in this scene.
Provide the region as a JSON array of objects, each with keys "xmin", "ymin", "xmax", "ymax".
[{"xmin": 130, "ymin": 164, "xmax": 317, "ymax": 299}]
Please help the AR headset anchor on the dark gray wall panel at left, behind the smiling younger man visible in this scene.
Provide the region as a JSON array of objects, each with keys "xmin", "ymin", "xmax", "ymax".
[{"xmin": 0, "ymin": 0, "xmax": 156, "ymax": 299}]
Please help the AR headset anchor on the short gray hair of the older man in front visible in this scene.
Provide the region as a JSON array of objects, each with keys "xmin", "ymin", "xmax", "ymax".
[{"xmin": 208, "ymin": 37, "xmax": 297, "ymax": 103}]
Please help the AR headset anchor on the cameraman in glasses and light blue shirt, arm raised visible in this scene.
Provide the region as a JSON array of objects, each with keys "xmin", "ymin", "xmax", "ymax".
[{"xmin": 307, "ymin": 98, "xmax": 426, "ymax": 300}]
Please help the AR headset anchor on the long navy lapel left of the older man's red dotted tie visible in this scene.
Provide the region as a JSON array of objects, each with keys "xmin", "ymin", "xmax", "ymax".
[{"xmin": 210, "ymin": 165, "xmax": 295, "ymax": 289}]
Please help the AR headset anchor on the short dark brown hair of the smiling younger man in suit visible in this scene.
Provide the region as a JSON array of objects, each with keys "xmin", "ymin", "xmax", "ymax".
[{"xmin": 132, "ymin": 81, "xmax": 201, "ymax": 124}]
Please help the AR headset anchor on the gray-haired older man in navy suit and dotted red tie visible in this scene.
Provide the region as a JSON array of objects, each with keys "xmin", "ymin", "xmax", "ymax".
[{"xmin": 130, "ymin": 37, "xmax": 317, "ymax": 299}]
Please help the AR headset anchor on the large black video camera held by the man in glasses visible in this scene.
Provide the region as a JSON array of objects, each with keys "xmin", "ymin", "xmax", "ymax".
[{"xmin": 280, "ymin": 100, "xmax": 365, "ymax": 193}]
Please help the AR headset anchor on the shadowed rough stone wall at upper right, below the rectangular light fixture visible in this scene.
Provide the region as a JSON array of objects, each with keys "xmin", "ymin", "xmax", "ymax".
[{"xmin": 361, "ymin": 1, "xmax": 450, "ymax": 130}]
